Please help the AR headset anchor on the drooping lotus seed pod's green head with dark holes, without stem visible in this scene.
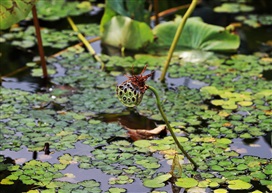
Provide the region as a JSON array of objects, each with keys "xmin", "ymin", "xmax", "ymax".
[{"xmin": 116, "ymin": 81, "xmax": 144, "ymax": 107}]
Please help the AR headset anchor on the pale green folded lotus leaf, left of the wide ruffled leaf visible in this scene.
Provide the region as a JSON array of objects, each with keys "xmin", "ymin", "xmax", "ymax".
[{"xmin": 102, "ymin": 16, "xmax": 153, "ymax": 50}]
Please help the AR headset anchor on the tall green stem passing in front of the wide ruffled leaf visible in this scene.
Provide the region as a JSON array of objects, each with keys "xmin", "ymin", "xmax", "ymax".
[{"xmin": 160, "ymin": 0, "xmax": 198, "ymax": 81}]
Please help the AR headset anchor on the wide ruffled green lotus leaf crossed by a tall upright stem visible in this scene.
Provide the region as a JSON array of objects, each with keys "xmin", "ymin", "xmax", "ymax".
[{"xmin": 153, "ymin": 16, "xmax": 240, "ymax": 52}]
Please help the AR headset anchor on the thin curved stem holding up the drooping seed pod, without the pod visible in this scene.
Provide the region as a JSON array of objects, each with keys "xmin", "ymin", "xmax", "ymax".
[{"xmin": 148, "ymin": 86, "xmax": 197, "ymax": 169}]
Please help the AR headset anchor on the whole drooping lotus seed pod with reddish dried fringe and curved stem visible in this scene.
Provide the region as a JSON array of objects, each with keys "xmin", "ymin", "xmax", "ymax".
[{"xmin": 116, "ymin": 66, "xmax": 197, "ymax": 169}]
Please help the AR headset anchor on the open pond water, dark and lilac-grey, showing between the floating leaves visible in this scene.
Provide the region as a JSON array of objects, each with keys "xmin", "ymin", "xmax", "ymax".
[{"xmin": 0, "ymin": 0, "xmax": 272, "ymax": 193}]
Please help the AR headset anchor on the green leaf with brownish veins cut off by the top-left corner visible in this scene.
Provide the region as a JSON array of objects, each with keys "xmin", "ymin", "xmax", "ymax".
[{"xmin": 0, "ymin": 0, "xmax": 36, "ymax": 29}]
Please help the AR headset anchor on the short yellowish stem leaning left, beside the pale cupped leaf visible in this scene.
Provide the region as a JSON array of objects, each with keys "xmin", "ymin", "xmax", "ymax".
[{"xmin": 67, "ymin": 17, "xmax": 105, "ymax": 70}]
